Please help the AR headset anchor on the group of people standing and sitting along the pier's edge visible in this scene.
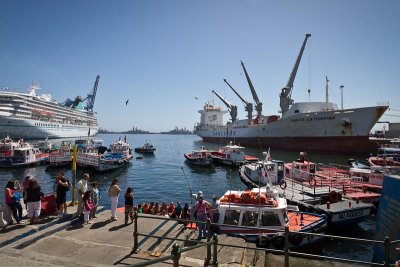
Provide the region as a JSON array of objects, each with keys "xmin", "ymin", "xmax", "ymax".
[{"xmin": 4, "ymin": 171, "xmax": 219, "ymax": 242}]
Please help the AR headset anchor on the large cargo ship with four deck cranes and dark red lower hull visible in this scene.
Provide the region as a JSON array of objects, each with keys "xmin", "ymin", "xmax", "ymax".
[{"xmin": 194, "ymin": 34, "xmax": 389, "ymax": 153}]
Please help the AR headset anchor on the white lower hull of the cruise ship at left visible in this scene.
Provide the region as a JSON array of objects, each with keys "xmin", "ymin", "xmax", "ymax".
[{"xmin": 0, "ymin": 117, "xmax": 98, "ymax": 139}]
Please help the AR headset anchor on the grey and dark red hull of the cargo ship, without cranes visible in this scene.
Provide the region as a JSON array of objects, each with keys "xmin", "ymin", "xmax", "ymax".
[{"xmin": 194, "ymin": 106, "xmax": 388, "ymax": 153}]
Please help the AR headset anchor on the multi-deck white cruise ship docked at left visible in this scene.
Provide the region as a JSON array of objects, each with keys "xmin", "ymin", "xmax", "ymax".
[{"xmin": 0, "ymin": 75, "xmax": 100, "ymax": 139}]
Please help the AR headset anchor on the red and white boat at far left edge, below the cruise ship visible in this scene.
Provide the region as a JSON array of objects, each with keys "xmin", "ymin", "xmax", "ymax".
[{"xmin": 0, "ymin": 136, "xmax": 49, "ymax": 167}]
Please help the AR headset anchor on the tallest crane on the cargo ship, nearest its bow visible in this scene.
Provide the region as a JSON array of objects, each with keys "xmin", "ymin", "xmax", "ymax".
[{"xmin": 279, "ymin": 33, "xmax": 311, "ymax": 115}]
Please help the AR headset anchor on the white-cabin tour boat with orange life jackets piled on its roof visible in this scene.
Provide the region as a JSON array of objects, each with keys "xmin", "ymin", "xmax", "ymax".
[{"xmin": 217, "ymin": 187, "xmax": 327, "ymax": 253}]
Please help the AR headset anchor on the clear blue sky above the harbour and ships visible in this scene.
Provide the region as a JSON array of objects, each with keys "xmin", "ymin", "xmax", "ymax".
[{"xmin": 0, "ymin": 0, "xmax": 400, "ymax": 131}]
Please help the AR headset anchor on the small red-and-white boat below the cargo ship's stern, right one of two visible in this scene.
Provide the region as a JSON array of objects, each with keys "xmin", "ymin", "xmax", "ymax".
[{"xmin": 210, "ymin": 141, "xmax": 258, "ymax": 167}]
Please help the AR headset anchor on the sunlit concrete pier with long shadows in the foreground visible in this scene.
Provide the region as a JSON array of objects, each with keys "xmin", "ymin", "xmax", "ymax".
[{"xmin": 0, "ymin": 207, "xmax": 362, "ymax": 267}]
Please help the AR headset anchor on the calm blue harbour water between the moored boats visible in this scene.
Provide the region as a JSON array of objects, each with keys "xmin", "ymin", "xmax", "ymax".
[{"xmin": 0, "ymin": 134, "xmax": 375, "ymax": 260}]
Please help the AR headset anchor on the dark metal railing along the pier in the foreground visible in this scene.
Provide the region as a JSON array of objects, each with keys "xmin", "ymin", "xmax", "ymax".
[{"xmin": 130, "ymin": 211, "xmax": 400, "ymax": 267}]
